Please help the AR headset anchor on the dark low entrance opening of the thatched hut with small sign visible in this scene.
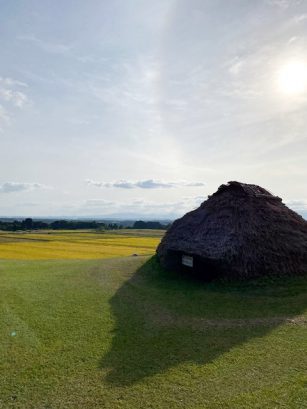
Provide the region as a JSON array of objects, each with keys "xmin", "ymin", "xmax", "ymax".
[{"xmin": 165, "ymin": 250, "xmax": 221, "ymax": 281}]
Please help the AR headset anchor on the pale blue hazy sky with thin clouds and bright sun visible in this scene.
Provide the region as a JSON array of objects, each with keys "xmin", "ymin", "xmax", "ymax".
[{"xmin": 0, "ymin": 0, "xmax": 307, "ymax": 218}]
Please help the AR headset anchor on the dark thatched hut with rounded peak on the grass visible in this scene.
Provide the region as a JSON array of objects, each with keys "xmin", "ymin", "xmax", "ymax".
[{"xmin": 157, "ymin": 182, "xmax": 307, "ymax": 279}]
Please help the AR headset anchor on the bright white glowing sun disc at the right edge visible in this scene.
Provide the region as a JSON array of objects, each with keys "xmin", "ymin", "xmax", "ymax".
[{"xmin": 277, "ymin": 61, "xmax": 307, "ymax": 95}]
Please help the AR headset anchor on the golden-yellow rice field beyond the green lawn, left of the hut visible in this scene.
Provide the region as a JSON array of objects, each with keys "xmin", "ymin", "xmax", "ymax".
[{"xmin": 0, "ymin": 231, "xmax": 163, "ymax": 260}]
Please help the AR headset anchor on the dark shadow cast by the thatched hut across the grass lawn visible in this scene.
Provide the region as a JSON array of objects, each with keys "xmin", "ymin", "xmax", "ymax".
[{"xmin": 101, "ymin": 257, "xmax": 307, "ymax": 386}]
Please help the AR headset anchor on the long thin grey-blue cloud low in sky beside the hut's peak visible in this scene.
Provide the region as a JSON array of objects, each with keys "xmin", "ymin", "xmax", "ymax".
[{"xmin": 86, "ymin": 179, "xmax": 205, "ymax": 189}]
